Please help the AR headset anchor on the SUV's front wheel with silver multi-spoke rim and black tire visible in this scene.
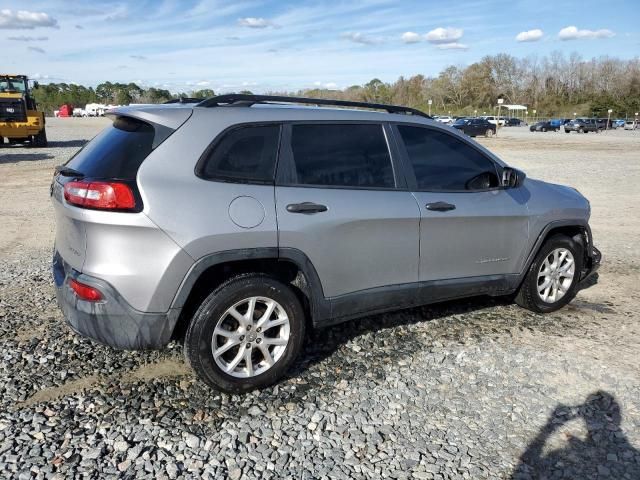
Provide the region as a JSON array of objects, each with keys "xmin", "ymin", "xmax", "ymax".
[{"xmin": 515, "ymin": 235, "xmax": 583, "ymax": 313}]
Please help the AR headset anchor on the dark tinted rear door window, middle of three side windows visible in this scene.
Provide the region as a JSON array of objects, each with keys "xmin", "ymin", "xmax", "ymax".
[{"xmin": 291, "ymin": 124, "xmax": 395, "ymax": 188}]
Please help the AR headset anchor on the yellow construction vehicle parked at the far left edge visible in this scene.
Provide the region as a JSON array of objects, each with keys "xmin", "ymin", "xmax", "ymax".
[{"xmin": 0, "ymin": 73, "xmax": 47, "ymax": 147}]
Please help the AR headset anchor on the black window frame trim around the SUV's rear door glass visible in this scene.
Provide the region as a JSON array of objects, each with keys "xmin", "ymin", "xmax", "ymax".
[{"xmin": 275, "ymin": 120, "xmax": 408, "ymax": 192}]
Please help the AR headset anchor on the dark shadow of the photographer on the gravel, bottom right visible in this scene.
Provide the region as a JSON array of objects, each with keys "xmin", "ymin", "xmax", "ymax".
[{"xmin": 511, "ymin": 391, "xmax": 640, "ymax": 480}]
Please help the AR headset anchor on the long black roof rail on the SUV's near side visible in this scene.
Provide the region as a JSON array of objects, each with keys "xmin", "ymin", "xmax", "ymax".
[{"xmin": 196, "ymin": 93, "xmax": 431, "ymax": 118}]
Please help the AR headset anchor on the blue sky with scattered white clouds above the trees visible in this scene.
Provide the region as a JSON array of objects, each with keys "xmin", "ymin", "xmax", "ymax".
[{"xmin": 0, "ymin": 0, "xmax": 640, "ymax": 92}]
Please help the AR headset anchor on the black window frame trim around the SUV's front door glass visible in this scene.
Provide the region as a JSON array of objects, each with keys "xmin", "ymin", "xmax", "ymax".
[{"xmin": 390, "ymin": 122, "xmax": 504, "ymax": 193}]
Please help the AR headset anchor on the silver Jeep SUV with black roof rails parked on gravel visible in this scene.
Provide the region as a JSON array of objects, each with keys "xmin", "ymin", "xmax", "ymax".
[{"xmin": 51, "ymin": 95, "xmax": 600, "ymax": 392}]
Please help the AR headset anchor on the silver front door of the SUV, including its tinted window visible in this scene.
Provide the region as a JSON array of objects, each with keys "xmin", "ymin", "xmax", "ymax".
[{"xmin": 394, "ymin": 125, "xmax": 528, "ymax": 281}]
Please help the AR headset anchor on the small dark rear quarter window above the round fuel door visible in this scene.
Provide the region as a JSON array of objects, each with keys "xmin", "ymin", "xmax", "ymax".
[{"xmin": 199, "ymin": 125, "xmax": 280, "ymax": 182}]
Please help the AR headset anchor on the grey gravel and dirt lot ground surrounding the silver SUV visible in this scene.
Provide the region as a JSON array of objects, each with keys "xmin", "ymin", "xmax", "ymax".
[{"xmin": 0, "ymin": 119, "xmax": 640, "ymax": 479}]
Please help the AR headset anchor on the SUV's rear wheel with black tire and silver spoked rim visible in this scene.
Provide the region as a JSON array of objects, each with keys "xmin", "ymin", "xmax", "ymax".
[{"xmin": 184, "ymin": 274, "xmax": 305, "ymax": 393}]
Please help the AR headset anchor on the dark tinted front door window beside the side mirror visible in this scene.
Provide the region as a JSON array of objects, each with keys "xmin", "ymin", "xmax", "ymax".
[{"xmin": 398, "ymin": 125, "xmax": 498, "ymax": 190}]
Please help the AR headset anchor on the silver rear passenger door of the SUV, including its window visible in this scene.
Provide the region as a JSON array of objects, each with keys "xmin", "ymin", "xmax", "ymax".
[{"xmin": 276, "ymin": 122, "xmax": 420, "ymax": 297}]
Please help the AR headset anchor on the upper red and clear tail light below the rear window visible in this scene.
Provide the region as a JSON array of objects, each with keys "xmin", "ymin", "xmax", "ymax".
[{"xmin": 64, "ymin": 180, "xmax": 136, "ymax": 210}]
